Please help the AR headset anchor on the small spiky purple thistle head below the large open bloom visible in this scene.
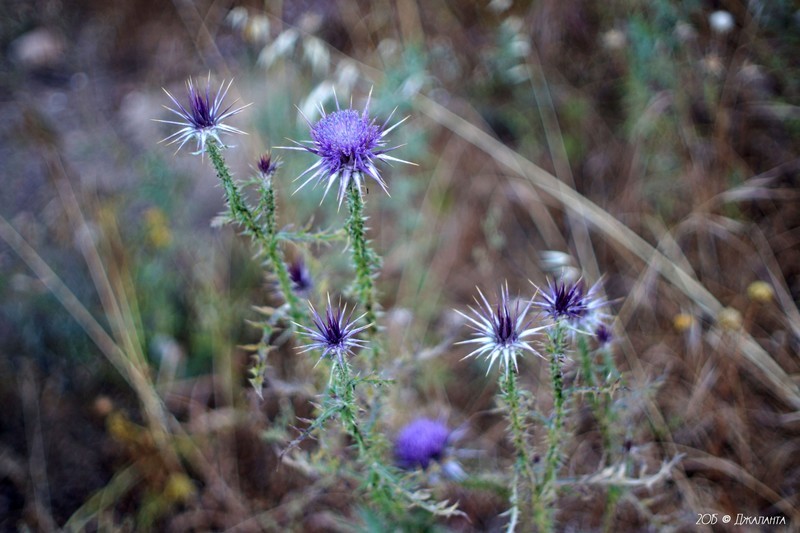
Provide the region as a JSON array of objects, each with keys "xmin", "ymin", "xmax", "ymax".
[{"xmin": 295, "ymin": 295, "xmax": 372, "ymax": 364}]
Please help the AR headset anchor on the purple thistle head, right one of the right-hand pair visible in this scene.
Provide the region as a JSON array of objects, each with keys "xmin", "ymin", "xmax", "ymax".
[{"xmin": 534, "ymin": 280, "xmax": 607, "ymax": 333}]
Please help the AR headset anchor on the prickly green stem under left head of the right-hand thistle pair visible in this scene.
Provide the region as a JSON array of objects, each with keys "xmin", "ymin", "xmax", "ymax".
[{"xmin": 499, "ymin": 367, "xmax": 534, "ymax": 529}]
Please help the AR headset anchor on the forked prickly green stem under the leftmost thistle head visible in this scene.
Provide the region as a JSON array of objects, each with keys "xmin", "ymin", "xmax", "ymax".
[{"xmin": 206, "ymin": 139, "xmax": 305, "ymax": 324}]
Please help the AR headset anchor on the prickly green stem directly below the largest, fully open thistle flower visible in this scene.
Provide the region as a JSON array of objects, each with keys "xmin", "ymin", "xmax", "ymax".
[{"xmin": 346, "ymin": 182, "xmax": 380, "ymax": 370}]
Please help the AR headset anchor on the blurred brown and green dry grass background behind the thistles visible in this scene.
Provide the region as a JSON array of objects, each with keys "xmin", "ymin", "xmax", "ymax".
[{"xmin": 0, "ymin": 0, "xmax": 800, "ymax": 531}]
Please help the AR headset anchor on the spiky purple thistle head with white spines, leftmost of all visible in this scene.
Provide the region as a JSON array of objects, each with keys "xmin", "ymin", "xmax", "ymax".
[{"xmin": 157, "ymin": 74, "xmax": 250, "ymax": 154}]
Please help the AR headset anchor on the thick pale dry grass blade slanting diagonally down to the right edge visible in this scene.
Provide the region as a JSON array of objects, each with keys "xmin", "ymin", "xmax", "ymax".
[{"xmin": 415, "ymin": 96, "xmax": 800, "ymax": 409}]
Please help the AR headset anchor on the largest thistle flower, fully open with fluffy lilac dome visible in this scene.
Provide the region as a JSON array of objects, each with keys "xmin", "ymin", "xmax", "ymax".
[{"xmin": 282, "ymin": 91, "xmax": 412, "ymax": 207}]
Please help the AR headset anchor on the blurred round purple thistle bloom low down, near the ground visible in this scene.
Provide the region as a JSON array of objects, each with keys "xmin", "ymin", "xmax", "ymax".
[{"xmin": 394, "ymin": 418, "xmax": 451, "ymax": 469}]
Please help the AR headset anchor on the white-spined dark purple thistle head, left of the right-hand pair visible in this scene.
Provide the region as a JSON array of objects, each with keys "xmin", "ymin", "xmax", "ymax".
[{"xmin": 456, "ymin": 283, "xmax": 544, "ymax": 374}]
